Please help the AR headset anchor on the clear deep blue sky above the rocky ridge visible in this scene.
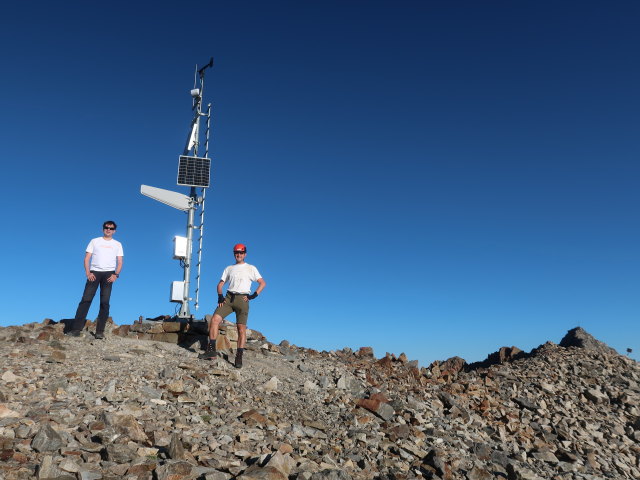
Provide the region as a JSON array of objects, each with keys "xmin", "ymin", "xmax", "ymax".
[{"xmin": 0, "ymin": 1, "xmax": 640, "ymax": 365}]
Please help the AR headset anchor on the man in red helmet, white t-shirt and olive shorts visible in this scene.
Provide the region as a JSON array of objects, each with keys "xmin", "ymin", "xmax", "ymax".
[{"xmin": 200, "ymin": 243, "xmax": 267, "ymax": 368}]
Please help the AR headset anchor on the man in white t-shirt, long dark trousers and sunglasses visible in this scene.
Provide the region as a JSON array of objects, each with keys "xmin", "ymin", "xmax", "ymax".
[{"xmin": 69, "ymin": 220, "xmax": 124, "ymax": 339}]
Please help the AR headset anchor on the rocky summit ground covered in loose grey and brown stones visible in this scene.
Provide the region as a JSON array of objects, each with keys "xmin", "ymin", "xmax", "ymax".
[{"xmin": 0, "ymin": 319, "xmax": 640, "ymax": 480}]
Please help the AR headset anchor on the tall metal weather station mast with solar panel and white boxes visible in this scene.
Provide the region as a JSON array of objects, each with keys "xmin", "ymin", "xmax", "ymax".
[{"xmin": 140, "ymin": 57, "xmax": 213, "ymax": 322}]
